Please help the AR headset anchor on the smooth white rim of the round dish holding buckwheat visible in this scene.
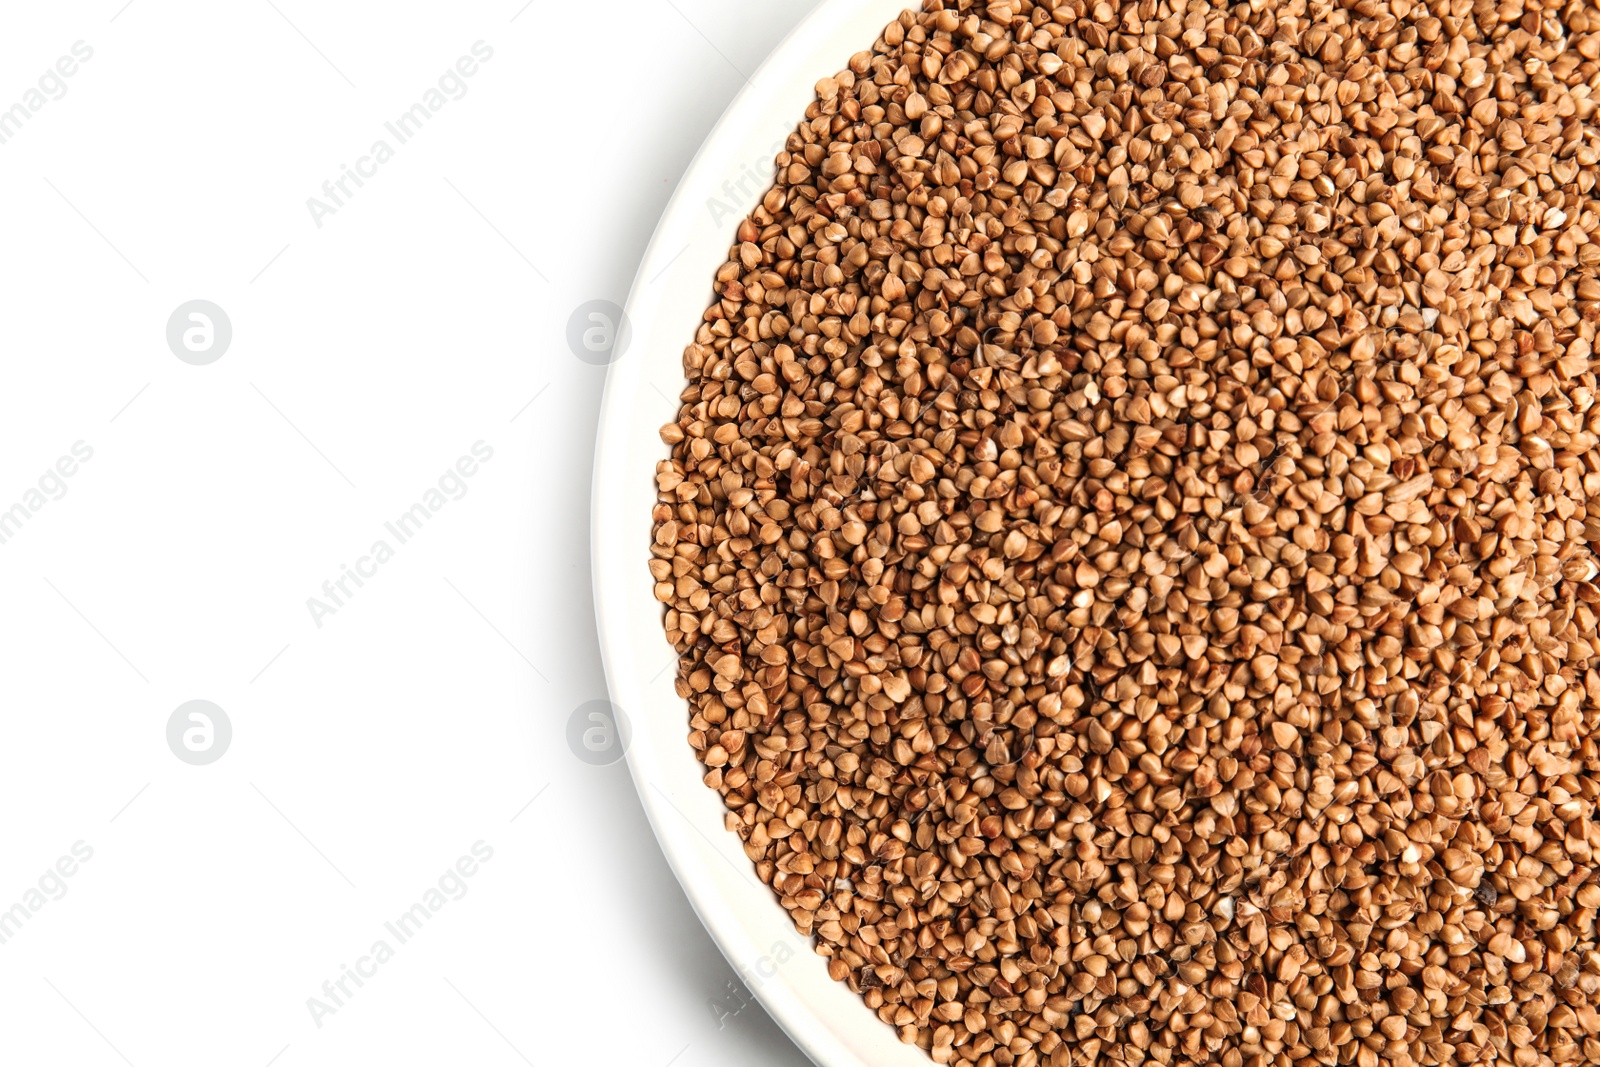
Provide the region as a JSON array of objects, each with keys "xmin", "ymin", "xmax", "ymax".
[{"xmin": 592, "ymin": 0, "xmax": 928, "ymax": 1067}]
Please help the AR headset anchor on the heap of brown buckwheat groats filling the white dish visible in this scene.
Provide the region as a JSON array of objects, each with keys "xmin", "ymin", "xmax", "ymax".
[{"xmin": 650, "ymin": 0, "xmax": 1600, "ymax": 1067}]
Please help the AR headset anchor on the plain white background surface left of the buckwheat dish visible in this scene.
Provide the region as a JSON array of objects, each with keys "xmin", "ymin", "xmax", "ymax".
[{"xmin": 0, "ymin": 0, "xmax": 838, "ymax": 1067}]
